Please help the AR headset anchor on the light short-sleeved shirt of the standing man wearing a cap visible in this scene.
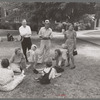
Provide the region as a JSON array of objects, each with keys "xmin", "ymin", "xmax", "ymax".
[{"xmin": 39, "ymin": 27, "xmax": 52, "ymax": 38}]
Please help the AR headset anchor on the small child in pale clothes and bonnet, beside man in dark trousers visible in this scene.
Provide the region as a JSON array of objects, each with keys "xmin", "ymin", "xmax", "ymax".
[{"xmin": 27, "ymin": 44, "xmax": 38, "ymax": 68}]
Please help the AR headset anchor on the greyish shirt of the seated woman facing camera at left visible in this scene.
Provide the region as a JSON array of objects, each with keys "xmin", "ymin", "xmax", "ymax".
[{"xmin": 10, "ymin": 53, "xmax": 25, "ymax": 64}]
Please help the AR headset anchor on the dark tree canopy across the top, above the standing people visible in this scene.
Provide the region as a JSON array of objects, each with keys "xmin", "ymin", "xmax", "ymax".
[{"xmin": 0, "ymin": 2, "xmax": 95, "ymax": 30}]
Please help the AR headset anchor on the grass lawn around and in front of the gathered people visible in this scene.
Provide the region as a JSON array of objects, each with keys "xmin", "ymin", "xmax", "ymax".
[{"xmin": 0, "ymin": 30, "xmax": 100, "ymax": 98}]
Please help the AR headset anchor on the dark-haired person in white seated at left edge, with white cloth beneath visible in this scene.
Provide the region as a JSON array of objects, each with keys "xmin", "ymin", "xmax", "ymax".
[{"xmin": 0, "ymin": 59, "xmax": 25, "ymax": 91}]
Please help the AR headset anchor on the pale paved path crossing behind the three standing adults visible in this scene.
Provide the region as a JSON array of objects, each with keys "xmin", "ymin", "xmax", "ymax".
[{"xmin": 0, "ymin": 29, "xmax": 100, "ymax": 45}]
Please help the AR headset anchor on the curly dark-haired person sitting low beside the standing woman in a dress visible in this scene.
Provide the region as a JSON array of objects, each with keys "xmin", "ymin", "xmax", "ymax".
[{"xmin": 52, "ymin": 49, "xmax": 65, "ymax": 73}]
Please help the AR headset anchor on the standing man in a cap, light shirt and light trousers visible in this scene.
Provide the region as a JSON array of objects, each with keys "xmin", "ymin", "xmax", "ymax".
[{"xmin": 38, "ymin": 20, "xmax": 52, "ymax": 63}]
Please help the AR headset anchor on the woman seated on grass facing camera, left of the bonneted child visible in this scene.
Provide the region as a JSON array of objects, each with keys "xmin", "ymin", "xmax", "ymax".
[{"xmin": 9, "ymin": 47, "xmax": 28, "ymax": 73}]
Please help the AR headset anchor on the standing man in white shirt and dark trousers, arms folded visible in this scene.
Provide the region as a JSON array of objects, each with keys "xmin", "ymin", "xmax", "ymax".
[{"xmin": 19, "ymin": 19, "xmax": 32, "ymax": 62}]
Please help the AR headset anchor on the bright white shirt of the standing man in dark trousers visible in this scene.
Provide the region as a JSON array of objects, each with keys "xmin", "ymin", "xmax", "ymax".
[{"xmin": 19, "ymin": 25, "xmax": 32, "ymax": 38}]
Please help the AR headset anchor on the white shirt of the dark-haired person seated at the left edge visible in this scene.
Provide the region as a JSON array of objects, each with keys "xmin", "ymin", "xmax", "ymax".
[{"xmin": 0, "ymin": 68, "xmax": 14, "ymax": 85}]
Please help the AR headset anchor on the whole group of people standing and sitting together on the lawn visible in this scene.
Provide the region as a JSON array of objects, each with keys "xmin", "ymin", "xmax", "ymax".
[{"xmin": 0, "ymin": 19, "xmax": 76, "ymax": 91}]
